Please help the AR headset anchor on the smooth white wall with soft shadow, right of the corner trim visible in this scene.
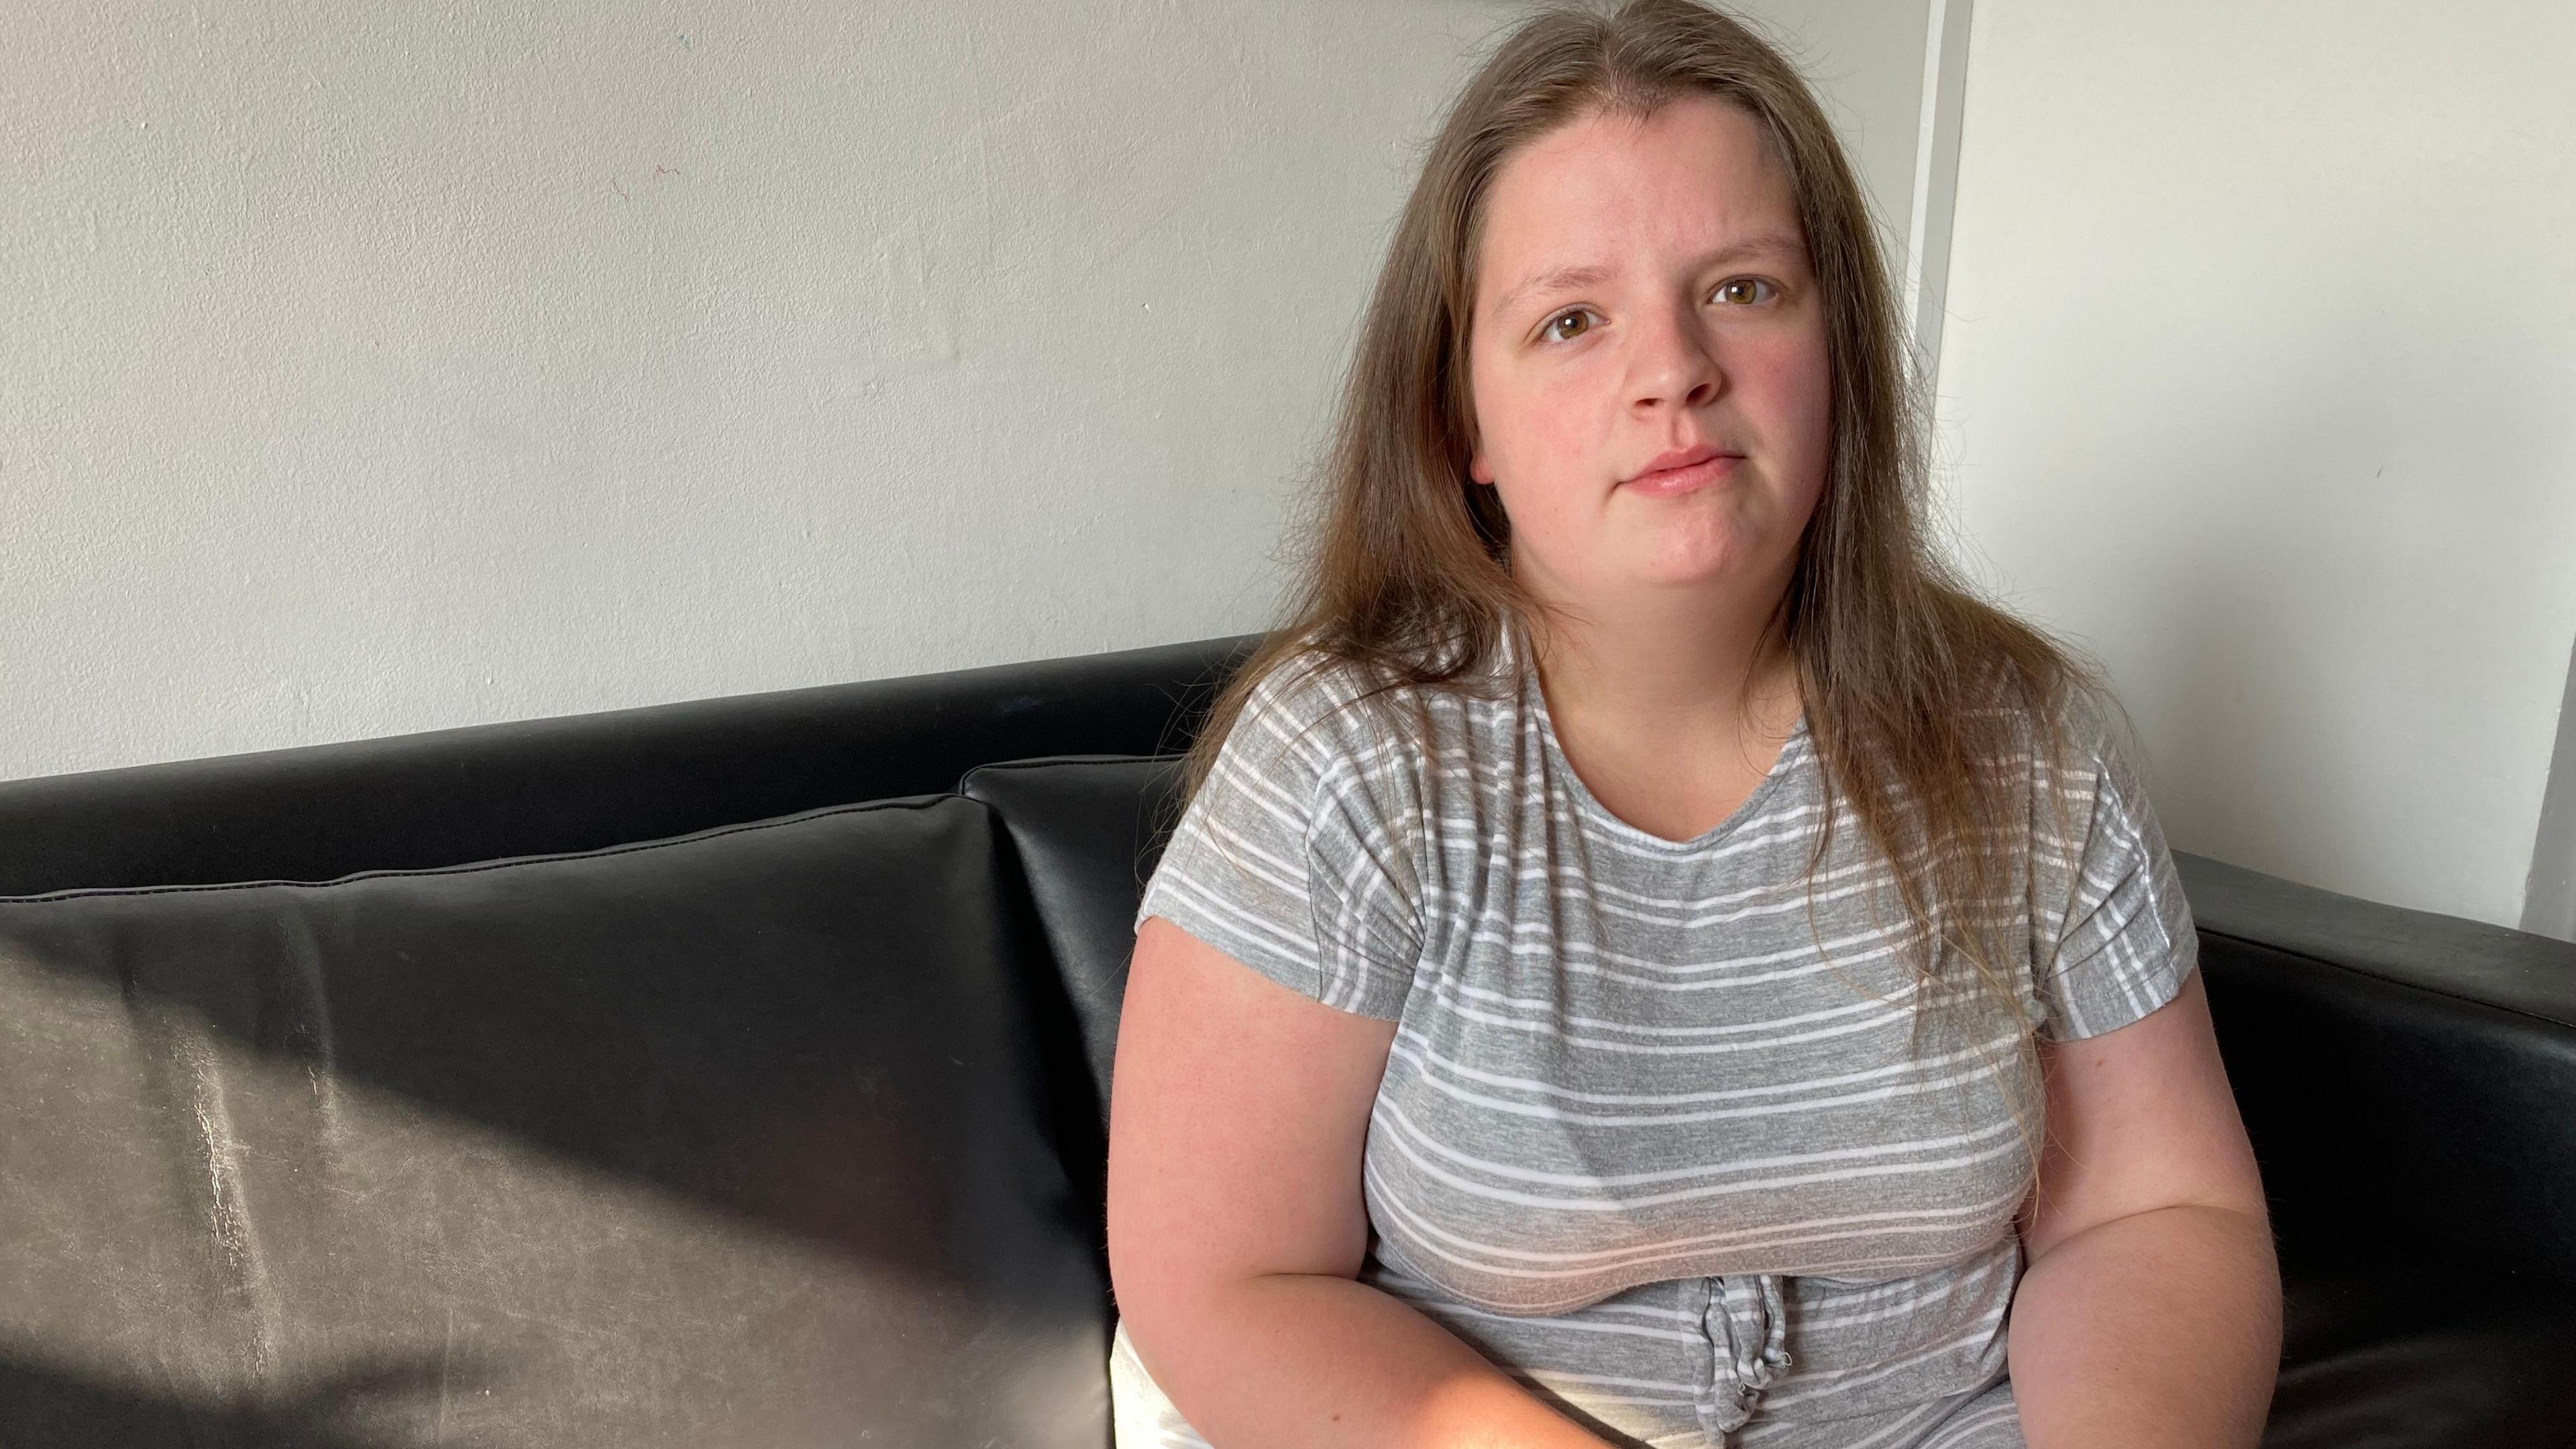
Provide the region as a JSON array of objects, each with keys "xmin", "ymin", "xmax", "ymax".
[{"xmin": 1940, "ymin": 0, "xmax": 2576, "ymax": 923}]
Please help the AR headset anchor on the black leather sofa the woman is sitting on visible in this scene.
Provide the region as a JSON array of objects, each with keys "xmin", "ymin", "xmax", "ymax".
[{"xmin": 0, "ymin": 639, "xmax": 2576, "ymax": 1449}]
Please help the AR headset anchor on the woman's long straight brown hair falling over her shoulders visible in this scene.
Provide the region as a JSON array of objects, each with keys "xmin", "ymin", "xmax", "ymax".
[{"xmin": 1183, "ymin": 0, "xmax": 2107, "ymax": 1181}]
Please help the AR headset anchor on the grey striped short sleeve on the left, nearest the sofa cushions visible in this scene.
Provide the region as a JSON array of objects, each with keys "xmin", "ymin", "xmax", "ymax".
[{"xmin": 1136, "ymin": 657, "xmax": 1422, "ymax": 1021}]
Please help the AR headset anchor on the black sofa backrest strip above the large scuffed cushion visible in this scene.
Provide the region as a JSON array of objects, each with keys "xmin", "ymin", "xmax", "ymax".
[{"xmin": 0, "ymin": 634, "xmax": 1260, "ymax": 895}]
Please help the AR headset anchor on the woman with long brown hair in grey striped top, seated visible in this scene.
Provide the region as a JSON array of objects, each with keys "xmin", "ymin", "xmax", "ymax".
[{"xmin": 1108, "ymin": 0, "xmax": 2279, "ymax": 1449}]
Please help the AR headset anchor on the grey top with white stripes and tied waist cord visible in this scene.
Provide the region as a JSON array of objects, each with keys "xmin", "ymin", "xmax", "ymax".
[{"xmin": 1110, "ymin": 624, "xmax": 2198, "ymax": 1449}]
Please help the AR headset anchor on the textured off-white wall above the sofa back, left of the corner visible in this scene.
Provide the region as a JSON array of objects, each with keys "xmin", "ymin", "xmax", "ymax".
[{"xmin": 0, "ymin": 0, "xmax": 1922, "ymax": 779}]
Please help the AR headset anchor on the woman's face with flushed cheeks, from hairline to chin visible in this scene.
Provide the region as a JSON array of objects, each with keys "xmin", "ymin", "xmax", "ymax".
[{"xmin": 1468, "ymin": 98, "xmax": 1831, "ymax": 614}]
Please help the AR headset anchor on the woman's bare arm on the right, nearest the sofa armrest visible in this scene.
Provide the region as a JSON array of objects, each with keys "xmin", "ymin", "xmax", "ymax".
[{"xmin": 2006, "ymin": 967, "xmax": 2279, "ymax": 1449}]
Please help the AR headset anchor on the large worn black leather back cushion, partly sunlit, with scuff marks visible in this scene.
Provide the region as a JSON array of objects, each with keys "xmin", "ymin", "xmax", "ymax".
[{"xmin": 0, "ymin": 797, "xmax": 1108, "ymax": 1449}]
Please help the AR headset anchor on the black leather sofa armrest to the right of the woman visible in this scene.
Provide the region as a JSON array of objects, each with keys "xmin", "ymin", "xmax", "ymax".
[{"xmin": 2174, "ymin": 853, "xmax": 2576, "ymax": 1287}]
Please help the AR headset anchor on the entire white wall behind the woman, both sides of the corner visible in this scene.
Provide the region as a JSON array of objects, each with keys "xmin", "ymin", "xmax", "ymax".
[{"xmin": 20, "ymin": 0, "xmax": 2576, "ymax": 920}]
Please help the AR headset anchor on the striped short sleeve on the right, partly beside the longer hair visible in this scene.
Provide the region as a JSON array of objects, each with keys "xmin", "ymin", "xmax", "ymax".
[{"xmin": 2030, "ymin": 706, "xmax": 2200, "ymax": 1042}]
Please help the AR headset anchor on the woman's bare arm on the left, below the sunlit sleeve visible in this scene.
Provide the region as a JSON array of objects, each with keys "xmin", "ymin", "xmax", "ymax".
[{"xmin": 1108, "ymin": 915, "xmax": 1605, "ymax": 1449}]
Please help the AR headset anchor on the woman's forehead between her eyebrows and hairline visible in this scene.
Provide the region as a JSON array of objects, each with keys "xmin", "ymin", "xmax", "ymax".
[{"xmin": 1476, "ymin": 95, "xmax": 1801, "ymax": 309}]
